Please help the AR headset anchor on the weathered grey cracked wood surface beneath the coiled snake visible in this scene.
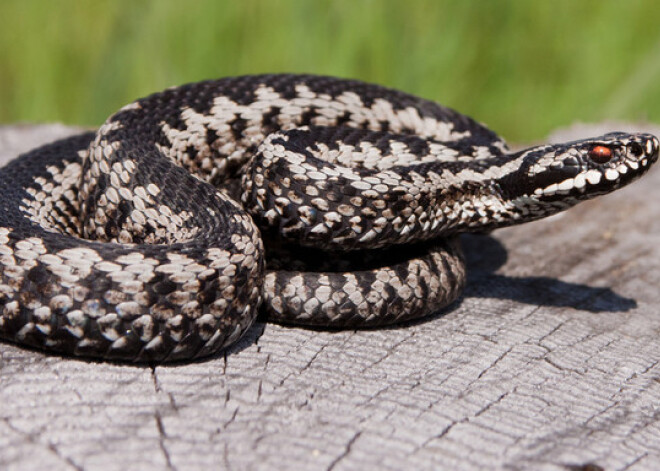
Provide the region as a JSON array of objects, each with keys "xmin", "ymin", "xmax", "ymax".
[{"xmin": 0, "ymin": 126, "xmax": 660, "ymax": 471}]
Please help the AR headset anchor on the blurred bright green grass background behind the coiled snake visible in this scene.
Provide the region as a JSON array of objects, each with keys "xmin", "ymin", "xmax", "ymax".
[{"xmin": 0, "ymin": 0, "xmax": 660, "ymax": 141}]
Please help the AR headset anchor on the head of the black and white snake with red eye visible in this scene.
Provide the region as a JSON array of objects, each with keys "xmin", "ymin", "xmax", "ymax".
[{"xmin": 511, "ymin": 132, "xmax": 660, "ymax": 206}]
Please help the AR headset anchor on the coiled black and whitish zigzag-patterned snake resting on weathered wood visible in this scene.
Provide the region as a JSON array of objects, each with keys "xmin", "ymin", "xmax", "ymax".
[{"xmin": 0, "ymin": 74, "xmax": 659, "ymax": 363}]
